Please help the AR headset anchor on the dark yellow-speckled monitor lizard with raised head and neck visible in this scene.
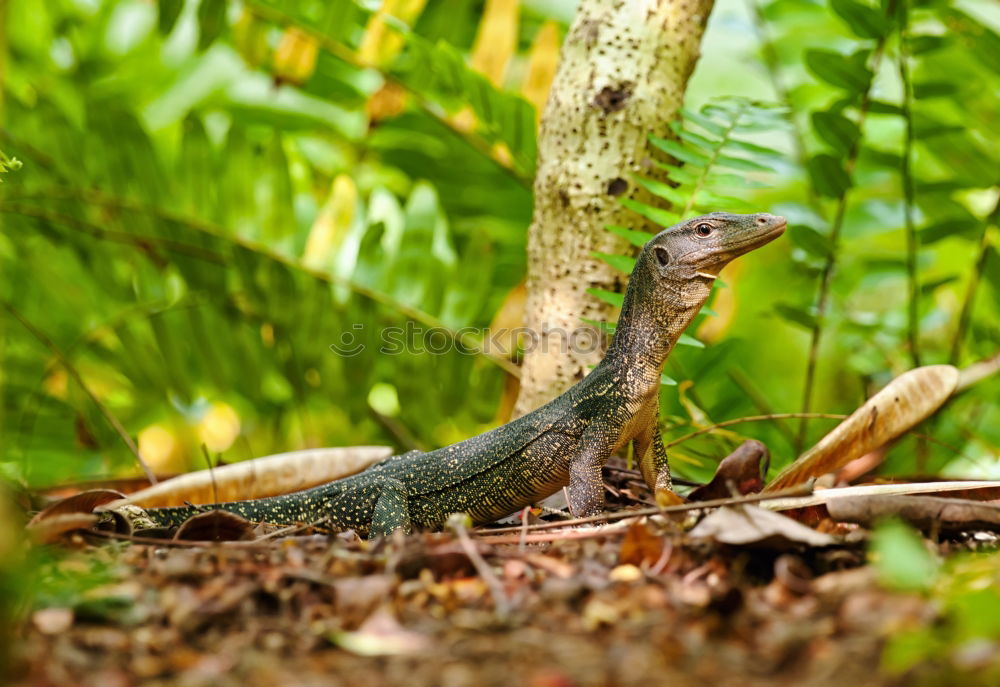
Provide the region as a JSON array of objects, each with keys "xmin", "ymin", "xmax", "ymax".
[{"xmin": 141, "ymin": 212, "xmax": 786, "ymax": 537}]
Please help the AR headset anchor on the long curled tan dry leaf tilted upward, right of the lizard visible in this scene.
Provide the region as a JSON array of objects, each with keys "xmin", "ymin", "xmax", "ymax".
[{"xmin": 764, "ymin": 365, "xmax": 959, "ymax": 492}]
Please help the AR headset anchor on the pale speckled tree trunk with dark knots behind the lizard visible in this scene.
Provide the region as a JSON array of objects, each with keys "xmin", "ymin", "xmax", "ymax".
[{"xmin": 514, "ymin": 0, "xmax": 712, "ymax": 416}]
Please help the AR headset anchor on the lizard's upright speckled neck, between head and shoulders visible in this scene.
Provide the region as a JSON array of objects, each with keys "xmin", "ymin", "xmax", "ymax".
[{"xmin": 603, "ymin": 269, "xmax": 711, "ymax": 393}]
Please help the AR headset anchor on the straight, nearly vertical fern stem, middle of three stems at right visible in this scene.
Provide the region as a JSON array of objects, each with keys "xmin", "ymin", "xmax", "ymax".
[{"xmin": 899, "ymin": 0, "xmax": 920, "ymax": 367}]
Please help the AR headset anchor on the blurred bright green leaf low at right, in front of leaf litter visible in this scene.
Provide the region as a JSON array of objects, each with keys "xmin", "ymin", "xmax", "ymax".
[{"xmin": 871, "ymin": 520, "xmax": 938, "ymax": 591}]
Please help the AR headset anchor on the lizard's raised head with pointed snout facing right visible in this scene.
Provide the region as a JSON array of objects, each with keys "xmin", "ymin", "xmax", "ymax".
[{"xmin": 643, "ymin": 212, "xmax": 786, "ymax": 284}]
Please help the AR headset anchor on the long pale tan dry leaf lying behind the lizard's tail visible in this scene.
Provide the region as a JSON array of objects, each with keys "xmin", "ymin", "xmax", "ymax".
[{"xmin": 106, "ymin": 446, "xmax": 392, "ymax": 509}]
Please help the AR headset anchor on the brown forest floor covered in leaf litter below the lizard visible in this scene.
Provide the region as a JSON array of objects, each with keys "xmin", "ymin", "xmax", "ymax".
[{"xmin": 11, "ymin": 464, "xmax": 992, "ymax": 687}]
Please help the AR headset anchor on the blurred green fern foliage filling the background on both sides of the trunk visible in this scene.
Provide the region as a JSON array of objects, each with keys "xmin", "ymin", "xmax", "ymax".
[{"xmin": 0, "ymin": 0, "xmax": 1000, "ymax": 494}]
